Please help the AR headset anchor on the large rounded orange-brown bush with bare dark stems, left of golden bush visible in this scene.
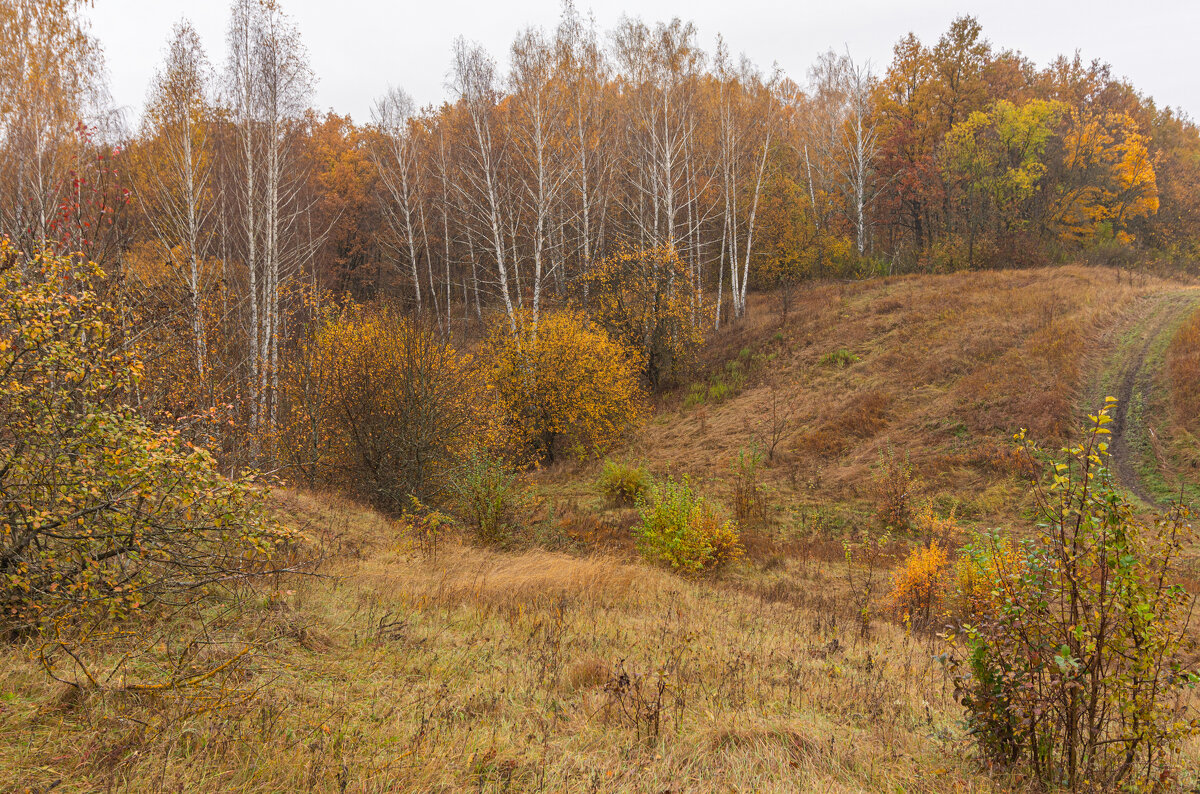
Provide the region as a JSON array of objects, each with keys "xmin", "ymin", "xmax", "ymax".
[{"xmin": 281, "ymin": 305, "xmax": 484, "ymax": 513}]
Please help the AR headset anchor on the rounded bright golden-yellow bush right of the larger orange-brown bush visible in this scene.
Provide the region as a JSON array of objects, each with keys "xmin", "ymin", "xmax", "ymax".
[{"xmin": 485, "ymin": 309, "xmax": 642, "ymax": 461}]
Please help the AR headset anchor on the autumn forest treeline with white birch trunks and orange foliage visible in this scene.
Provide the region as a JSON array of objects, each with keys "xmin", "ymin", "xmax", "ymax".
[{"xmin": 7, "ymin": 0, "xmax": 1200, "ymax": 453}]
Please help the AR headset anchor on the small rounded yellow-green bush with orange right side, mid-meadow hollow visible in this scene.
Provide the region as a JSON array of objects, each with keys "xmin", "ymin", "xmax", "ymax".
[{"xmin": 634, "ymin": 477, "xmax": 742, "ymax": 573}]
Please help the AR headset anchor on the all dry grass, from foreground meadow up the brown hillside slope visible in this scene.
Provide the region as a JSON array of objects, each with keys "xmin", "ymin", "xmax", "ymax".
[{"xmin": 0, "ymin": 267, "xmax": 1200, "ymax": 792}]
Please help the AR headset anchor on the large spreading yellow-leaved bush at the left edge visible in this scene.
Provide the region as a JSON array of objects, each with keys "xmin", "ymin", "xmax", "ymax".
[{"xmin": 0, "ymin": 241, "xmax": 288, "ymax": 652}]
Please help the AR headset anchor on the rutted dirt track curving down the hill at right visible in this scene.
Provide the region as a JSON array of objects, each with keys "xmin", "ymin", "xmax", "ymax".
[{"xmin": 1099, "ymin": 290, "xmax": 1198, "ymax": 506}]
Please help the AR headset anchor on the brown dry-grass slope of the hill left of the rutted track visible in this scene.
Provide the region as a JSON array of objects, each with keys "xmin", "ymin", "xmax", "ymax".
[{"xmin": 630, "ymin": 267, "xmax": 1178, "ymax": 523}]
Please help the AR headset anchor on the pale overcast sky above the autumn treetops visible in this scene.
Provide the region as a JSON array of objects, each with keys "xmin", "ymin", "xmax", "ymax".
[{"xmin": 88, "ymin": 0, "xmax": 1200, "ymax": 121}]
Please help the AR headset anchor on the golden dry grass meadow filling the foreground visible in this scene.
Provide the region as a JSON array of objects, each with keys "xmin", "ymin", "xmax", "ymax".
[{"xmin": 0, "ymin": 494, "xmax": 1051, "ymax": 792}]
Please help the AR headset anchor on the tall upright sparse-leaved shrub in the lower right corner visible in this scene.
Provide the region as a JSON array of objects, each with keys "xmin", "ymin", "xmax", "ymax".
[{"xmin": 952, "ymin": 398, "xmax": 1200, "ymax": 792}]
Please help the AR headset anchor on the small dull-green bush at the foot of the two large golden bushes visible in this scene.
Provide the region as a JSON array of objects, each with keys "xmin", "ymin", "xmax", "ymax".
[{"xmin": 451, "ymin": 450, "xmax": 530, "ymax": 543}]
